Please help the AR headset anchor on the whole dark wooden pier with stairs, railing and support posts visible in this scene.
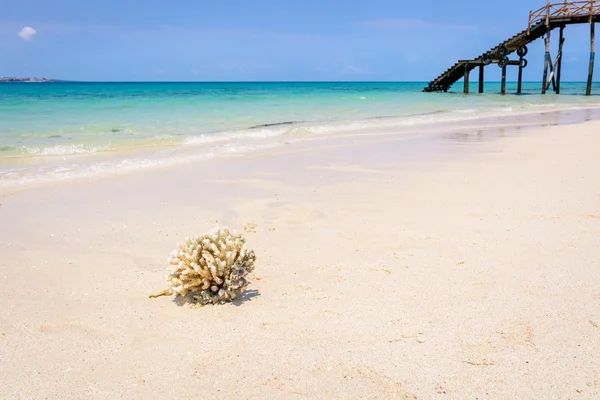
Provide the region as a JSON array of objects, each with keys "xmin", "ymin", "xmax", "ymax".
[{"xmin": 423, "ymin": 0, "xmax": 600, "ymax": 96}]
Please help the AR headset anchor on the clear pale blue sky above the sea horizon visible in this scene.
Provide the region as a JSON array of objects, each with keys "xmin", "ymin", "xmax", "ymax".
[{"xmin": 0, "ymin": 0, "xmax": 600, "ymax": 81}]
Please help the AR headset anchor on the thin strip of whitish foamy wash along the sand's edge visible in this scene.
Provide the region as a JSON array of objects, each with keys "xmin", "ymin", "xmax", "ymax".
[{"xmin": 0, "ymin": 107, "xmax": 600, "ymax": 193}]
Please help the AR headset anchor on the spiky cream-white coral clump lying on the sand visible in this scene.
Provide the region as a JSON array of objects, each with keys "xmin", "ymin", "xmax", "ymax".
[{"xmin": 155, "ymin": 228, "xmax": 256, "ymax": 305}]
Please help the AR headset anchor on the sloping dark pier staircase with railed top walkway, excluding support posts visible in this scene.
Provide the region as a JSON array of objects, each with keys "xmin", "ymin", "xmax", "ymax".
[{"xmin": 423, "ymin": 0, "xmax": 600, "ymax": 92}]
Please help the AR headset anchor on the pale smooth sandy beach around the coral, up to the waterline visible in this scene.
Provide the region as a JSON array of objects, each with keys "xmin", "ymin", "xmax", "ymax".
[{"xmin": 0, "ymin": 118, "xmax": 600, "ymax": 399}]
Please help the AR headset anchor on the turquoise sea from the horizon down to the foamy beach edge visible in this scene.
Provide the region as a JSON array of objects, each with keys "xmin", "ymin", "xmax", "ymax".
[{"xmin": 0, "ymin": 82, "xmax": 600, "ymax": 189}]
